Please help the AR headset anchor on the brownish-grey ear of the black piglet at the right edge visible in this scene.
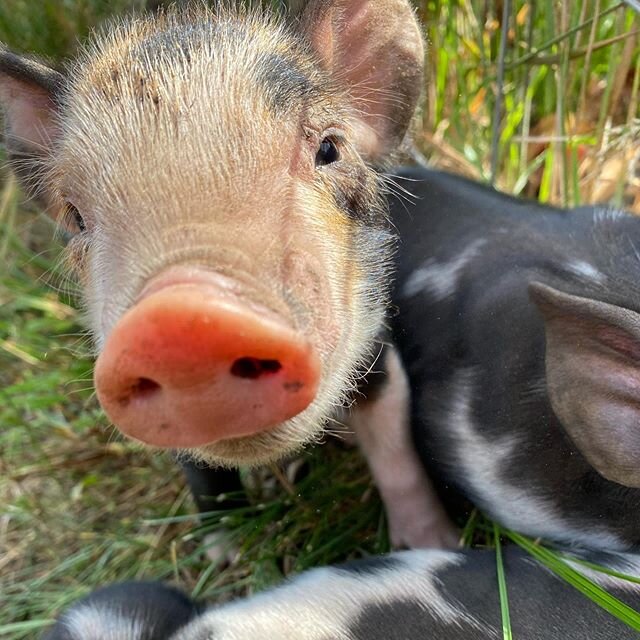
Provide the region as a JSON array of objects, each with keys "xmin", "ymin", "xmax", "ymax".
[{"xmin": 529, "ymin": 282, "xmax": 640, "ymax": 487}]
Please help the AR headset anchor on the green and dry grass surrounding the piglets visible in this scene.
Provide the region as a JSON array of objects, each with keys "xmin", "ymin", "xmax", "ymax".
[{"xmin": 0, "ymin": 0, "xmax": 640, "ymax": 640}]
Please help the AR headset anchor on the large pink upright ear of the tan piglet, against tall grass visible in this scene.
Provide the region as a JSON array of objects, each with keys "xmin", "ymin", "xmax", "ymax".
[{"xmin": 302, "ymin": 0, "xmax": 424, "ymax": 162}]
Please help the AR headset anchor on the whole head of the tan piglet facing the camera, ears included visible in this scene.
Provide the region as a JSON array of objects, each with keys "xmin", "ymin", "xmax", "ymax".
[{"xmin": 0, "ymin": 0, "xmax": 422, "ymax": 464}]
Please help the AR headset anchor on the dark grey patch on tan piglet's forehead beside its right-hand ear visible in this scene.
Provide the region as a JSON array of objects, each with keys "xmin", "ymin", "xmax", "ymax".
[{"xmin": 257, "ymin": 54, "xmax": 313, "ymax": 112}]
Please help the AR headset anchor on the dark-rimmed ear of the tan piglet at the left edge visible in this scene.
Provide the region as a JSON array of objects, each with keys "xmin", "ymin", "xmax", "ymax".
[{"xmin": 0, "ymin": 44, "xmax": 64, "ymax": 205}]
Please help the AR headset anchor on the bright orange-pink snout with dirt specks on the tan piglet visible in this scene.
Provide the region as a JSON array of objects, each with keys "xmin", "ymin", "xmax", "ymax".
[{"xmin": 95, "ymin": 269, "xmax": 320, "ymax": 448}]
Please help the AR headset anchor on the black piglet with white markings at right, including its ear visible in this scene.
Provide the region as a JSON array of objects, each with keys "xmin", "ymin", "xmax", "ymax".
[{"xmin": 392, "ymin": 169, "xmax": 640, "ymax": 550}]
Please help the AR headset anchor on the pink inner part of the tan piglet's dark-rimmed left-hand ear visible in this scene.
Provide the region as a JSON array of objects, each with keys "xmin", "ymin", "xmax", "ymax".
[{"xmin": 0, "ymin": 75, "xmax": 56, "ymax": 153}]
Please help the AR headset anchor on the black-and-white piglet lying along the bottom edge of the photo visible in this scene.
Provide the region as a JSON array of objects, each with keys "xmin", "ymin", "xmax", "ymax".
[{"xmin": 41, "ymin": 547, "xmax": 640, "ymax": 640}]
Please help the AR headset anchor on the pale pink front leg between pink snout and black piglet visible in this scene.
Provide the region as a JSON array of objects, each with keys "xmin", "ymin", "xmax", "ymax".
[{"xmin": 349, "ymin": 346, "xmax": 459, "ymax": 548}]
